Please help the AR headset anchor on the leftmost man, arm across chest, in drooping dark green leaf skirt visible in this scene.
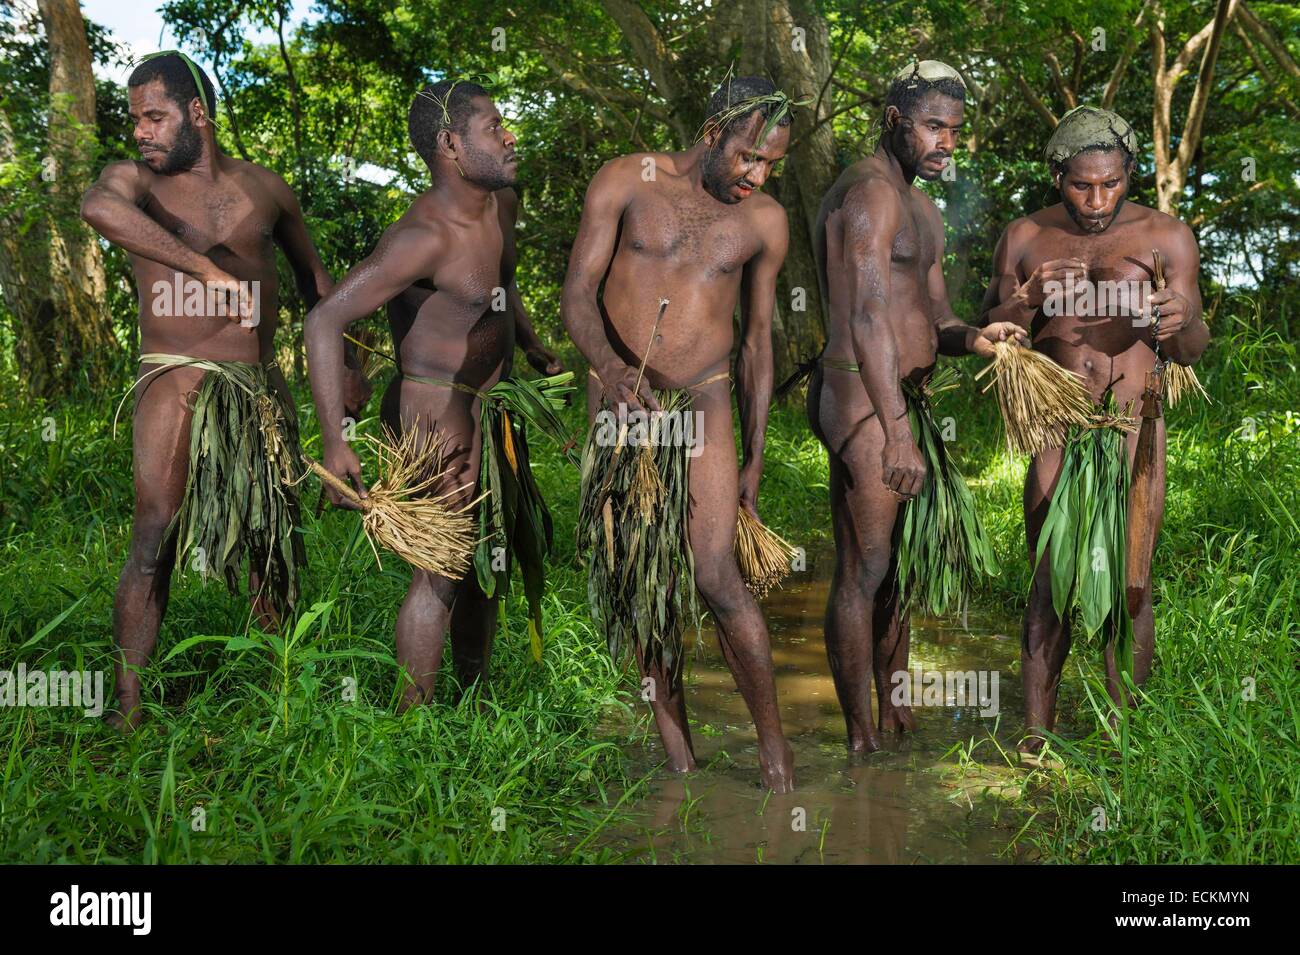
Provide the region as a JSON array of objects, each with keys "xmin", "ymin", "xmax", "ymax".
[{"xmin": 82, "ymin": 51, "xmax": 361, "ymax": 732}]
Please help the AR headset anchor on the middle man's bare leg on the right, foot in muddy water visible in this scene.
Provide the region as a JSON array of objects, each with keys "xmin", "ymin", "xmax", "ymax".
[{"xmin": 689, "ymin": 382, "xmax": 794, "ymax": 793}]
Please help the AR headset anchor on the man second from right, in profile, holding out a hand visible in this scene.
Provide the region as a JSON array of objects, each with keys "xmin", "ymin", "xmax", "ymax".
[{"xmin": 807, "ymin": 60, "xmax": 1024, "ymax": 752}]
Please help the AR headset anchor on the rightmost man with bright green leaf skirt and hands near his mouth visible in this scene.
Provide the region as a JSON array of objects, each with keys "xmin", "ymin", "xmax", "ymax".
[{"xmin": 983, "ymin": 100, "xmax": 1209, "ymax": 754}]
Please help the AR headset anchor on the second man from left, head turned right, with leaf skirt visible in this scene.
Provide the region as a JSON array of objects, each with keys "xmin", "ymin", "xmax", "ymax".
[{"xmin": 307, "ymin": 81, "xmax": 567, "ymax": 709}]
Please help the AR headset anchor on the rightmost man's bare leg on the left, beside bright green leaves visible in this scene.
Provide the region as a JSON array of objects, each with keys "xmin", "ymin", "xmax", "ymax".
[{"xmin": 1018, "ymin": 448, "xmax": 1070, "ymax": 755}]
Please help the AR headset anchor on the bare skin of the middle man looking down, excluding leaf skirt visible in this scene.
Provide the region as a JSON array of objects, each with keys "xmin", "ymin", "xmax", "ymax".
[{"xmin": 562, "ymin": 112, "xmax": 794, "ymax": 793}]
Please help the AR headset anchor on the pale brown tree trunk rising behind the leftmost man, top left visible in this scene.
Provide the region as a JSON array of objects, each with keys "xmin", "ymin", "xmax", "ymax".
[{"xmin": 39, "ymin": 0, "xmax": 120, "ymax": 391}]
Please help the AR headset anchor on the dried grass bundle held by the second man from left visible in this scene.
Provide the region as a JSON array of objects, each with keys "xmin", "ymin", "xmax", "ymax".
[{"xmin": 303, "ymin": 427, "xmax": 482, "ymax": 581}]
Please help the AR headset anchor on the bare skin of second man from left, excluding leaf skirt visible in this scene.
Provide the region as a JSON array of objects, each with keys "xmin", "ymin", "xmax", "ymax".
[{"xmin": 306, "ymin": 96, "xmax": 560, "ymax": 709}]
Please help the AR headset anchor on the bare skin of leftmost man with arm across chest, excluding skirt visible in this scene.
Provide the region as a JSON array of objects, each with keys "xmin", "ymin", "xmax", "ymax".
[{"xmin": 81, "ymin": 81, "xmax": 342, "ymax": 732}]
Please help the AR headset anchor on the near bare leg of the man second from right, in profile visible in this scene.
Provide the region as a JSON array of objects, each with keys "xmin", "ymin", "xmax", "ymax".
[{"xmin": 809, "ymin": 372, "xmax": 911, "ymax": 752}]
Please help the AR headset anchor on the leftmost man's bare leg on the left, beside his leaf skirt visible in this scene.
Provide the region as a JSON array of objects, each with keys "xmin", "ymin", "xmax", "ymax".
[{"xmin": 105, "ymin": 365, "xmax": 203, "ymax": 733}]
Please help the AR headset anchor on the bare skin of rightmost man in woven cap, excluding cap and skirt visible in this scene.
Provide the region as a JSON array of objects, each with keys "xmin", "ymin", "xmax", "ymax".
[{"xmin": 983, "ymin": 148, "xmax": 1209, "ymax": 754}]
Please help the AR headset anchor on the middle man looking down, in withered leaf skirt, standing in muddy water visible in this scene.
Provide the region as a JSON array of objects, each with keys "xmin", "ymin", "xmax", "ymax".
[{"xmin": 562, "ymin": 77, "xmax": 794, "ymax": 791}]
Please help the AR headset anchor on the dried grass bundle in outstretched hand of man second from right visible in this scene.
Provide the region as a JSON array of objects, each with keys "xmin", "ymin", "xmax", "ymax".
[{"xmin": 975, "ymin": 342, "xmax": 1092, "ymax": 455}]
